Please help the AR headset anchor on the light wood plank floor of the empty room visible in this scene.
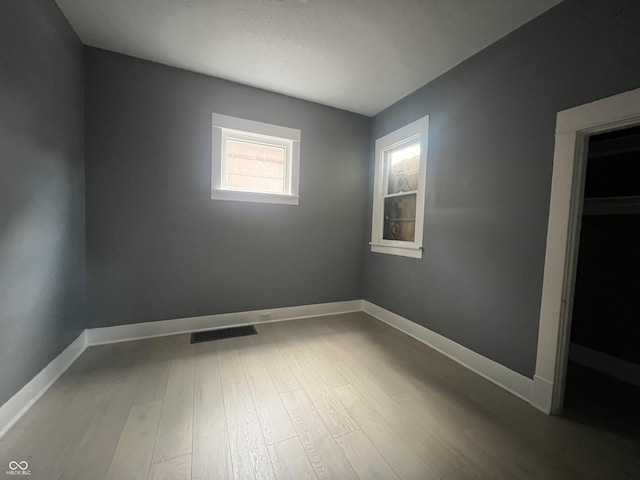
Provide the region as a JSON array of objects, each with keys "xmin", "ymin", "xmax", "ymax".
[{"xmin": 0, "ymin": 313, "xmax": 640, "ymax": 480}]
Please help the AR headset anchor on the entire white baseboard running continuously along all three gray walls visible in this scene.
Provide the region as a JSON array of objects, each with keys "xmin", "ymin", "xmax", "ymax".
[{"xmin": 0, "ymin": 300, "xmax": 548, "ymax": 438}]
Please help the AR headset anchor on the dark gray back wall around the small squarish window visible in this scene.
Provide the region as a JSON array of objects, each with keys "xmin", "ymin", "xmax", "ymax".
[{"xmin": 85, "ymin": 48, "xmax": 370, "ymax": 327}]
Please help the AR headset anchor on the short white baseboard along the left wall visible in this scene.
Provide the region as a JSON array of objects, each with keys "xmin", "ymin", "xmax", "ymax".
[{"xmin": 0, "ymin": 330, "xmax": 87, "ymax": 438}]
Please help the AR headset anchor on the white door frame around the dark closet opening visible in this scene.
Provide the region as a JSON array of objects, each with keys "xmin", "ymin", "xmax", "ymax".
[{"xmin": 530, "ymin": 88, "xmax": 640, "ymax": 414}]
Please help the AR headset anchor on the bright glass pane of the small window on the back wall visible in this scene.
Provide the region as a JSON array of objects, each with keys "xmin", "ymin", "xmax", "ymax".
[{"xmin": 225, "ymin": 139, "xmax": 287, "ymax": 193}]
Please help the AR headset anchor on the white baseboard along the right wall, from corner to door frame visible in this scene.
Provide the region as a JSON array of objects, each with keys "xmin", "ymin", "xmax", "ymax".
[{"xmin": 363, "ymin": 300, "xmax": 535, "ymax": 406}]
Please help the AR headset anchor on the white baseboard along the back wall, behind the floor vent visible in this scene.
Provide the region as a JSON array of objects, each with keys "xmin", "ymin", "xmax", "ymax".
[{"xmin": 87, "ymin": 300, "xmax": 362, "ymax": 345}]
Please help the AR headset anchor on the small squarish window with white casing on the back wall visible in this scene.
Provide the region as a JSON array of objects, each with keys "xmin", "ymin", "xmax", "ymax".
[{"xmin": 211, "ymin": 113, "xmax": 300, "ymax": 205}]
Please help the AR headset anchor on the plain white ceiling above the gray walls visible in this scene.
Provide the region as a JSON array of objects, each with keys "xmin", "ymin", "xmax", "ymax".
[{"xmin": 57, "ymin": 0, "xmax": 561, "ymax": 115}]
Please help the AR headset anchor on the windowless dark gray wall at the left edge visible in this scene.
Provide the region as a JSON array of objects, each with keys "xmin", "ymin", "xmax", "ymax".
[{"xmin": 0, "ymin": 0, "xmax": 86, "ymax": 405}]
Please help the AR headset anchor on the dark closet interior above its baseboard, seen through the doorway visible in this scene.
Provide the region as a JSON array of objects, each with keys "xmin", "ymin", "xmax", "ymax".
[{"xmin": 571, "ymin": 126, "xmax": 640, "ymax": 364}]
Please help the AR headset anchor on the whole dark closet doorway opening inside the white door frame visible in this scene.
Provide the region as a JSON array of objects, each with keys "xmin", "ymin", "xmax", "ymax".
[{"xmin": 563, "ymin": 126, "xmax": 640, "ymax": 438}]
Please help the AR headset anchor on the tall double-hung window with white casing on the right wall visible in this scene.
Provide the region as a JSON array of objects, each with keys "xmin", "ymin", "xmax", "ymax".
[{"xmin": 371, "ymin": 116, "xmax": 429, "ymax": 258}]
